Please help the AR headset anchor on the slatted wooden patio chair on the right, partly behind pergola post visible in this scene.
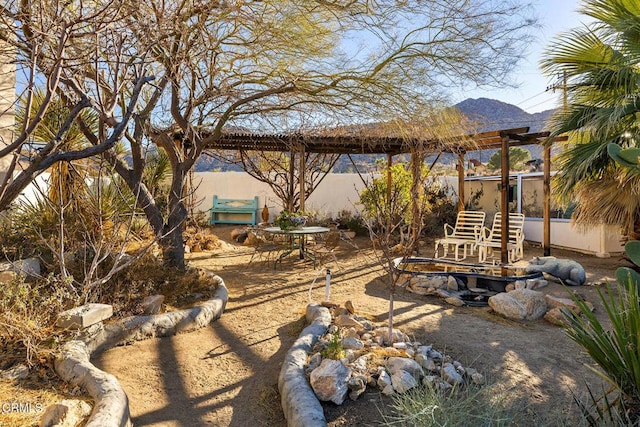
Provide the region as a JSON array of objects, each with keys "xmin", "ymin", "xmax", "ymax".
[{"xmin": 478, "ymin": 212, "xmax": 525, "ymax": 263}]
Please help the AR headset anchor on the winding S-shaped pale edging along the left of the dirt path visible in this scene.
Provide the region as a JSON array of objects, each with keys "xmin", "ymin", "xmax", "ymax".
[{"xmin": 55, "ymin": 273, "xmax": 229, "ymax": 427}]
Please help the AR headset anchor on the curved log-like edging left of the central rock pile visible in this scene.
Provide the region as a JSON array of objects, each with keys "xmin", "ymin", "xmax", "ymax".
[{"xmin": 278, "ymin": 305, "xmax": 331, "ymax": 427}]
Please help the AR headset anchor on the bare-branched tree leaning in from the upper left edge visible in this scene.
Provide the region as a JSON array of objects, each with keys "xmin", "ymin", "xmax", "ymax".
[{"xmin": 0, "ymin": 0, "xmax": 153, "ymax": 210}]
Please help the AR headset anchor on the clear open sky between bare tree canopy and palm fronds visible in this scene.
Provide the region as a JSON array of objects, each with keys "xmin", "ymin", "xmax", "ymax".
[{"xmin": 454, "ymin": 0, "xmax": 587, "ymax": 113}]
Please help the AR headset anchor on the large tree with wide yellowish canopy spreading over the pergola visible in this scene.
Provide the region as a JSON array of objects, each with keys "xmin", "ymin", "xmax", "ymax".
[{"xmin": 3, "ymin": 0, "xmax": 533, "ymax": 268}]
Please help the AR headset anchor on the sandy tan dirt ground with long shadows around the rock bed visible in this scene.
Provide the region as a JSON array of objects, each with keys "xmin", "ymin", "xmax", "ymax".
[{"xmin": 94, "ymin": 226, "xmax": 623, "ymax": 427}]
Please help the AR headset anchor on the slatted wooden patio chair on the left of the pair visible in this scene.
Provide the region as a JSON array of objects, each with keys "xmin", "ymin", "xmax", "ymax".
[{"xmin": 434, "ymin": 211, "xmax": 486, "ymax": 261}]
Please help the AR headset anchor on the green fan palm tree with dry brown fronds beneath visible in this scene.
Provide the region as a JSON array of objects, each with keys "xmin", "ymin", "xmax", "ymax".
[{"xmin": 541, "ymin": 0, "xmax": 640, "ymax": 237}]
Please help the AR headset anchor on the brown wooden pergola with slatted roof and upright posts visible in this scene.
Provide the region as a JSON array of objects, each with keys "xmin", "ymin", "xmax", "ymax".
[{"xmin": 206, "ymin": 127, "xmax": 567, "ymax": 265}]
